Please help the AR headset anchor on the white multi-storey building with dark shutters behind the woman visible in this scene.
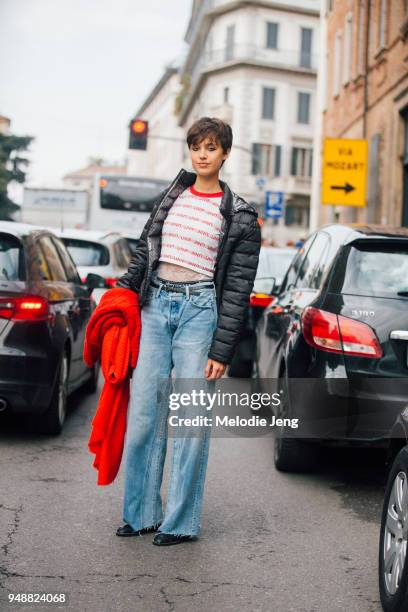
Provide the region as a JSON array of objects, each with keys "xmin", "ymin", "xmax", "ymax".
[{"xmin": 175, "ymin": 0, "xmax": 319, "ymax": 242}]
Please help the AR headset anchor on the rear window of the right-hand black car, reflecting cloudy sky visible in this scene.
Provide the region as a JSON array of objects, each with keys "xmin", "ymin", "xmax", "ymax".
[{"xmin": 341, "ymin": 243, "xmax": 408, "ymax": 297}]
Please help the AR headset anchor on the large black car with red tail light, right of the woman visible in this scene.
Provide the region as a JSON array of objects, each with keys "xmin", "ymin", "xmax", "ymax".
[{"xmin": 254, "ymin": 225, "xmax": 408, "ymax": 471}]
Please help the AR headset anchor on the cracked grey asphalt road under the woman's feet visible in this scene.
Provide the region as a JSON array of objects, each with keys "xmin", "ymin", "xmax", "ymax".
[{"xmin": 0, "ymin": 380, "xmax": 385, "ymax": 612}]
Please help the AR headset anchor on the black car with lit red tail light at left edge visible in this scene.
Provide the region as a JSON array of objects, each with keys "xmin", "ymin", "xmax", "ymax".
[{"xmin": 0, "ymin": 222, "xmax": 102, "ymax": 434}]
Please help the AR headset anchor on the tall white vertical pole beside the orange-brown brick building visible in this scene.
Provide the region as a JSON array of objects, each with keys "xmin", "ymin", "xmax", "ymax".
[{"xmin": 309, "ymin": 0, "xmax": 327, "ymax": 233}]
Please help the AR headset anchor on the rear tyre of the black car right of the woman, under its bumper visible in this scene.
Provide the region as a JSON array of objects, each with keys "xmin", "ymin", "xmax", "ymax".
[{"xmin": 274, "ymin": 373, "xmax": 318, "ymax": 472}]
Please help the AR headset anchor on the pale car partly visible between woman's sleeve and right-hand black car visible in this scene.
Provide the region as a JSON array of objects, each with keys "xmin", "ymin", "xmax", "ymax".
[{"xmin": 227, "ymin": 246, "xmax": 296, "ymax": 378}]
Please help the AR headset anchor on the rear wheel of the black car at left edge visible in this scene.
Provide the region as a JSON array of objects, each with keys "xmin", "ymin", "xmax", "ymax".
[{"xmin": 36, "ymin": 351, "xmax": 69, "ymax": 435}]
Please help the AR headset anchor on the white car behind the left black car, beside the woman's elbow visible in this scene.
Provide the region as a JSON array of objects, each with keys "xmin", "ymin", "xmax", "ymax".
[{"xmin": 56, "ymin": 229, "xmax": 132, "ymax": 303}]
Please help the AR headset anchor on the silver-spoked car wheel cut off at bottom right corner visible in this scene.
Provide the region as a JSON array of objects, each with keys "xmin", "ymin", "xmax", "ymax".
[{"xmin": 378, "ymin": 447, "xmax": 408, "ymax": 612}]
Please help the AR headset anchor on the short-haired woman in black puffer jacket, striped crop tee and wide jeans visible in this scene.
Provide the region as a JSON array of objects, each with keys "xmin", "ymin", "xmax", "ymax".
[{"xmin": 116, "ymin": 117, "xmax": 261, "ymax": 546}]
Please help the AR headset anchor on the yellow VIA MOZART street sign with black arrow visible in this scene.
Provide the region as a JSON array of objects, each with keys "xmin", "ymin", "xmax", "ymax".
[{"xmin": 322, "ymin": 138, "xmax": 368, "ymax": 206}]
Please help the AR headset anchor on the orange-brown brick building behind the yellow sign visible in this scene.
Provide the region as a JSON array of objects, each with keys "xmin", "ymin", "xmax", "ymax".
[{"xmin": 319, "ymin": 0, "xmax": 408, "ymax": 226}]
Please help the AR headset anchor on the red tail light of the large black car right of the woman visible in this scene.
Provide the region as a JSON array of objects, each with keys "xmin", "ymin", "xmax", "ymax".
[{"xmin": 302, "ymin": 306, "xmax": 382, "ymax": 358}]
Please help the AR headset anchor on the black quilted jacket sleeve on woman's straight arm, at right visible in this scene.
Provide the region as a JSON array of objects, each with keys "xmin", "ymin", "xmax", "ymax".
[{"xmin": 208, "ymin": 213, "xmax": 261, "ymax": 364}]
